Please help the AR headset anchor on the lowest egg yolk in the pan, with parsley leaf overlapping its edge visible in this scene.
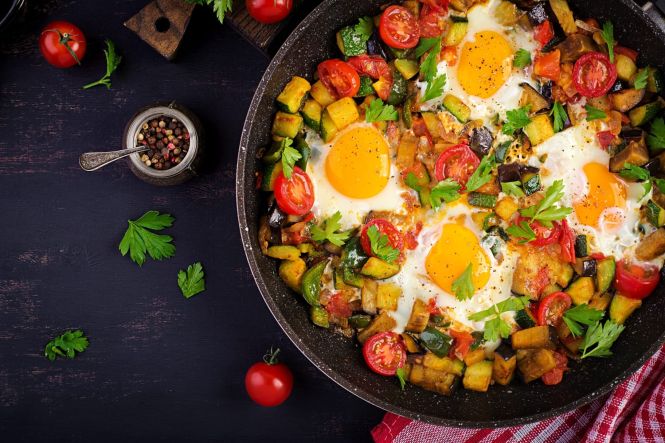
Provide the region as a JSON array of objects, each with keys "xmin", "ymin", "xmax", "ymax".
[{"xmin": 425, "ymin": 224, "xmax": 490, "ymax": 294}]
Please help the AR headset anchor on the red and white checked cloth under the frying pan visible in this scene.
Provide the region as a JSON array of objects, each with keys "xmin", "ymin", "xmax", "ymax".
[{"xmin": 372, "ymin": 346, "xmax": 665, "ymax": 443}]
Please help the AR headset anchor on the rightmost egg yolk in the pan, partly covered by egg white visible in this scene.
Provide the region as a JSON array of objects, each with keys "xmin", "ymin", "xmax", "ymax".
[{"xmin": 573, "ymin": 163, "xmax": 626, "ymax": 228}]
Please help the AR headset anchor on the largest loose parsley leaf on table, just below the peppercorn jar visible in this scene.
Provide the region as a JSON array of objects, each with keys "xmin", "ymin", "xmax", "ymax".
[{"xmin": 118, "ymin": 211, "xmax": 175, "ymax": 266}]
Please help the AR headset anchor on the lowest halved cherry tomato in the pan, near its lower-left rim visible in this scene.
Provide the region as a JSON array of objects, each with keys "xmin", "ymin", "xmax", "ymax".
[{"xmin": 363, "ymin": 332, "xmax": 406, "ymax": 375}]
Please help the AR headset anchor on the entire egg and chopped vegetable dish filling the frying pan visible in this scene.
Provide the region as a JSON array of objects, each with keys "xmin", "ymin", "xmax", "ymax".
[{"xmin": 257, "ymin": 0, "xmax": 665, "ymax": 395}]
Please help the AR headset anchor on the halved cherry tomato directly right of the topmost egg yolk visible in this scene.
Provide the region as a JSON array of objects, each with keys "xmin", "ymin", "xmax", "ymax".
[{"xmin": 573, "ymin": 52, "xmax": 617, "ymax": 97}]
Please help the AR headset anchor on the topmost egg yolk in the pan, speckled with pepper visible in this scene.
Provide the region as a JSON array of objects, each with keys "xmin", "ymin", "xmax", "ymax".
[{"xmin": 457, "ymin": 31, "xmax": 513, "ymax": 98}]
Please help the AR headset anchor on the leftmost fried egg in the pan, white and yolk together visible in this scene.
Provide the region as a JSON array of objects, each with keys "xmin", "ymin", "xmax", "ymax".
[{"xmin": 306, "ymin": 123, "xmax": 407, "ymax": 229}]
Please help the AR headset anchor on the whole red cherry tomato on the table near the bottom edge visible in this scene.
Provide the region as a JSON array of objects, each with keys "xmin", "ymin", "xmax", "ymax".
[{"xmin": 245, "ymin": 349, "xmax": 293, "ymax": 406}]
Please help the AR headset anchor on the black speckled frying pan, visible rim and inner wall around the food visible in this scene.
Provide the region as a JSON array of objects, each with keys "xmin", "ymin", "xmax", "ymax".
[{"xmin": 236, "ymin": 0, "xmax": 665, "ymax": 428}]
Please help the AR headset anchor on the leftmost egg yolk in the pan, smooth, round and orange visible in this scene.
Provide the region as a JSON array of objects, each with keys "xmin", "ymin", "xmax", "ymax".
[{"xmin": 326, "ymin": 126, "xmax": 390, "ymax": 198}]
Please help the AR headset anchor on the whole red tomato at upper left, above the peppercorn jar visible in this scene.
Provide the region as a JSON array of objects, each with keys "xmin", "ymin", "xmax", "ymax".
[{"xmin": 39, "ymin": 21, "xmax": 88, "ymax": 68}]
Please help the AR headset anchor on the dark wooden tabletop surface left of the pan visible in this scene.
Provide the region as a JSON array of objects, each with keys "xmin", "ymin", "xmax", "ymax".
[{"xmin": 0, "ymin": 0, "xmax": 382, "ymax": 442}]
